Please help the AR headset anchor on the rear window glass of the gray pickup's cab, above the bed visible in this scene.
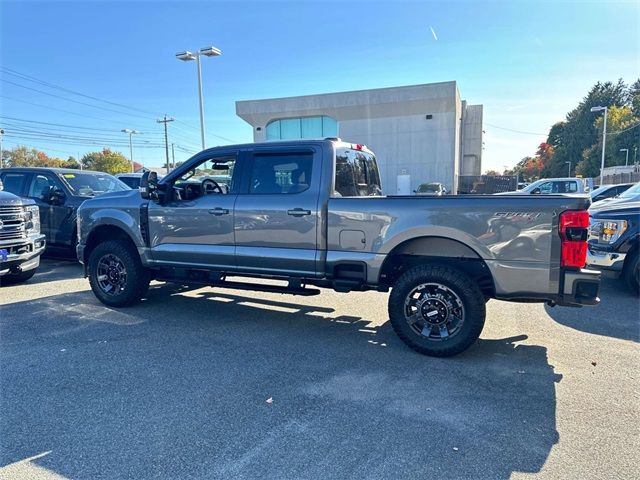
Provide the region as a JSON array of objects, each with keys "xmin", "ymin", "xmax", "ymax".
[{"xmin": 332, "ymin": 147, "xmax": 382, "ymax": 197}]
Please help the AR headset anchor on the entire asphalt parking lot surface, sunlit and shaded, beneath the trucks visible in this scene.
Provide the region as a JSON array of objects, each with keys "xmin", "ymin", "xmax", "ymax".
[{"xmin": 0, "ymin": 259, "xmax": 640, "ymax": 479}]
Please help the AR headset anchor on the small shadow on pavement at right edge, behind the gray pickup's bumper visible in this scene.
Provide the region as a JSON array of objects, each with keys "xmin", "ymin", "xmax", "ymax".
[{"xmin": 544, "ymin": 277, "xmax": 640, "ymax": 342}]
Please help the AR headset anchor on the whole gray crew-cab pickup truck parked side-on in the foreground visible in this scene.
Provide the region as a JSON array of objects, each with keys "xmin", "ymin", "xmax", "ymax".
[{"xmin": 77, "ymin": 138, "xmax": 600, "ymax": 356}]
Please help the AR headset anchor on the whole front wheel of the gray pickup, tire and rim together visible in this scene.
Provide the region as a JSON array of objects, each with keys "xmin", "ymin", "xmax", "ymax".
[{"xmin": 88, "ymin": 240, "xmax": 150, "ymax": 307}]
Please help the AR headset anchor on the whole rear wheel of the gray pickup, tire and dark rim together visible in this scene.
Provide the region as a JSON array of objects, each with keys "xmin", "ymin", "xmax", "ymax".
[{"xmin": 389, "ymin": 265, "xmax": 486, "ymax": 357}]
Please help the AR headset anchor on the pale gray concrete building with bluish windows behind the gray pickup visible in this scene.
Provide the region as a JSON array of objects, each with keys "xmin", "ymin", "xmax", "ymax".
[{"xmin": 236, "ymin": 82, "xmax": 482, "ymax": 194}]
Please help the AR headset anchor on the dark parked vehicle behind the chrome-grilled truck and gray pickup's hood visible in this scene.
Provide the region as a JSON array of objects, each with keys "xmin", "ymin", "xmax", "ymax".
[{"xmin": 0, "ymin": 167, "xmax": 128, "ymax": 253}]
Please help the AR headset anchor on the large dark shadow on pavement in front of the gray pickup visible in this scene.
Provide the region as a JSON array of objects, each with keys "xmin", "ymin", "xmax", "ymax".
[{"xmin": 0, "ymin": 286, "xmax": 561, "ymax": 479}]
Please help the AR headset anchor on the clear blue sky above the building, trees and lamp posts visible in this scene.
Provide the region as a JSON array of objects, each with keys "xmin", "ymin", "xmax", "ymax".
[{"xmin": 0, "ymin": 0, "xmax": 640, "ymax": 170}]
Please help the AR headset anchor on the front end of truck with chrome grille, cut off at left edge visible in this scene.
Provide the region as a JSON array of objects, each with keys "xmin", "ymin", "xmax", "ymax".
[{"xmin": 0, "ymin": 188, "xmax": 46, "ymax": 285}]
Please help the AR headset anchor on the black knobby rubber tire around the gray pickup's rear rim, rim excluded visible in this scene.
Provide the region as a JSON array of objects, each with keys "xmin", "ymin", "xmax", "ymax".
[{"xmin": 389, "ymin": 264, "xmax": 486, "ymax": 357}]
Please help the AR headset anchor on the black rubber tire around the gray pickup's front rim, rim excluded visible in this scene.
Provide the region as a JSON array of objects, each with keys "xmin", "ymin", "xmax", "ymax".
[{"xmin": 88, "ymin": 240, "xmax": 151, "ymax": 307}]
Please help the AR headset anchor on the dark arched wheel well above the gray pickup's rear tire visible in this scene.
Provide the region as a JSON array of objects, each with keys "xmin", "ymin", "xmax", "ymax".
[{"xmin": 380, "ymin": 237, "xmax": 495, "ymax": 297}]
